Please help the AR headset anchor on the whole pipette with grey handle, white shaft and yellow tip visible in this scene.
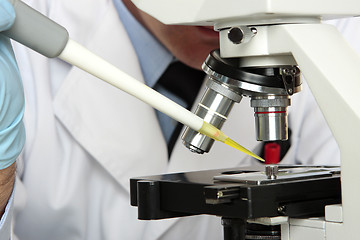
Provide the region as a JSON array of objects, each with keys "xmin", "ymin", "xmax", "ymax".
[{"xmin": 4, "ymin": 0, "xmax": 264, "ymax": 161}]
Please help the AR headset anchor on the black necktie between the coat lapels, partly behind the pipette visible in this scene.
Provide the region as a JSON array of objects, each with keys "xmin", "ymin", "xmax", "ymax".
[{"xmin": 154, "ymin": 62, "xmax": 205, "ymax": 158}]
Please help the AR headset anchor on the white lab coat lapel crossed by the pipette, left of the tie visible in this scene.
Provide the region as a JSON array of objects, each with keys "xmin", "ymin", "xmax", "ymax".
[{"xmin": 54, "ymin": 1, "xmax": 167, "ymax": 190}]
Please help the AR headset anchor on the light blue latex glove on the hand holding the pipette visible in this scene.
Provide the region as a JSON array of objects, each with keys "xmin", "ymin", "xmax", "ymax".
[{"xmin": 0, "ymin": 0, "xmax": 25, "ymax": 169}]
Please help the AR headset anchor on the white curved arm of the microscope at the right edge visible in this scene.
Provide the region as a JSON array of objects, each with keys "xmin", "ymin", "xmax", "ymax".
[{"xmin": 256, "ymin": 24, "xmax": 360, "ymax": 239}]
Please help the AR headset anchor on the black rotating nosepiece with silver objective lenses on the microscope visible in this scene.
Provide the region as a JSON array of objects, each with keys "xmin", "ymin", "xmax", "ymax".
[{"xmin": 182, "ymin": 50, "xmax": 301, "ymax": 154}]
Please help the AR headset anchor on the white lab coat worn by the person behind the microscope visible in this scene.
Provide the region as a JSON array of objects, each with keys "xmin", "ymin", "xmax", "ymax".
[{"xmin": 10, "ymin": 0, "xmax": 339, "ymax": 240}]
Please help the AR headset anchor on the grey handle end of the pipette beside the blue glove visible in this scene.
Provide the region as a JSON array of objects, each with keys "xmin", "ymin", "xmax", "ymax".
[{"xmin": 3, "ymin": 0, "xmax": 69, "ymax": 58}]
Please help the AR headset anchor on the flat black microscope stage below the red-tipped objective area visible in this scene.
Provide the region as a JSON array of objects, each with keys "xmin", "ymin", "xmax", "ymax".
[{"xmin": 130, "ymin": 165, "xmax": 341, "ymax": 220}]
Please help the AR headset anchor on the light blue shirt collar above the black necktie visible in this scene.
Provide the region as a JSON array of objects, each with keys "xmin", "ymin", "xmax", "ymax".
[{"xmin": 113, "ymin": 0, "xmax": 174, "ymax": 87}]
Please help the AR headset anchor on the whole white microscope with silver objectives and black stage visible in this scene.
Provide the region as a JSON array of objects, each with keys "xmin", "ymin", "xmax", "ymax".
[{"xmin": 130, "ymin": 0, "xmax": 360, "ymax": 240}]
